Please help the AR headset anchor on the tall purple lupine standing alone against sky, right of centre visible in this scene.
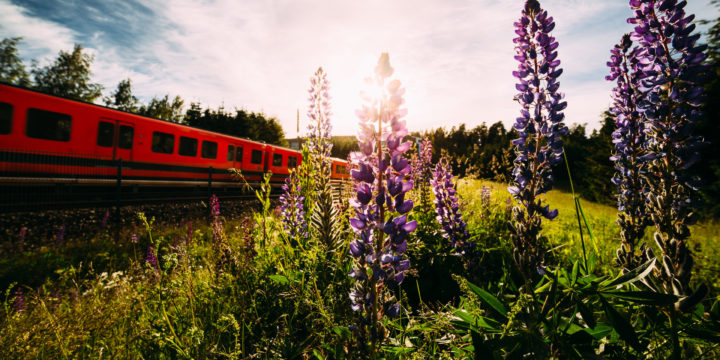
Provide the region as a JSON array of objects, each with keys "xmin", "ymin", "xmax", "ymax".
[{"xmin": 508, "ymin": 0, "xmax": 568, "ymax": 281}]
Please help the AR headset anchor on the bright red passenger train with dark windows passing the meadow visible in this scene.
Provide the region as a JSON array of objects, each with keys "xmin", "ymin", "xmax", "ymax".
[{"xmin": 0, "ymin": 83, "xmax": 349, "ymax": 193}]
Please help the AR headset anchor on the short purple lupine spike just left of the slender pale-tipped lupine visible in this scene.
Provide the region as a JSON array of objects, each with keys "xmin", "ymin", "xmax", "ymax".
[{"xmin": 280, "ymin": 171, "xmax": 308, "ymax": 242}]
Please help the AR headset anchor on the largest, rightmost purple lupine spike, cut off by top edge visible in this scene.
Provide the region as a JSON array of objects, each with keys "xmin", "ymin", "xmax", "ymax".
[{"xmin": 628, "ymin": 0, "xmax": 707, "ymax": 304}]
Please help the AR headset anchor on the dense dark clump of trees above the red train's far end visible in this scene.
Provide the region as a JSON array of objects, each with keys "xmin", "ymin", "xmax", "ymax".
[{"xmin": 184, "ymin": 103, "xmax": 287, "ymax": 146}]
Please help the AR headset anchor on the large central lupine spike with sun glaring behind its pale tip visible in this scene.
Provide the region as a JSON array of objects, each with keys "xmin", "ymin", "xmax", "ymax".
[{"xmin": 350, "ymin": 53, "xmax": 417, "ymax": 344}]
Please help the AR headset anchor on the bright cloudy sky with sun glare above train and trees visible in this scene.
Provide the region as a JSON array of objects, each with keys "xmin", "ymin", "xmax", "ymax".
[{"xmin": 0, "ymin": 0, "xmax": 720, "ymax": 137}]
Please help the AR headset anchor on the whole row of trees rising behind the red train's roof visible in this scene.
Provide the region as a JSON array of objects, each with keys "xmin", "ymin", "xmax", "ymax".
[{"xmin": 0, "ymin": 37, "xmax": 287, "ymax": 145}]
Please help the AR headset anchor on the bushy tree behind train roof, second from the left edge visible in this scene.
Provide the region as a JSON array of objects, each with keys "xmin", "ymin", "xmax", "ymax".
[{"xmin": 32, "ymin": 44, "xmax": 103, "ymax": 102}]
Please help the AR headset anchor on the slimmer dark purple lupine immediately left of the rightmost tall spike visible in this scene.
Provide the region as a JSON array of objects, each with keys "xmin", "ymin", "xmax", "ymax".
[{"xmin": 606, "ymin": 34, "xmax": 649, "ymax": 272}]
